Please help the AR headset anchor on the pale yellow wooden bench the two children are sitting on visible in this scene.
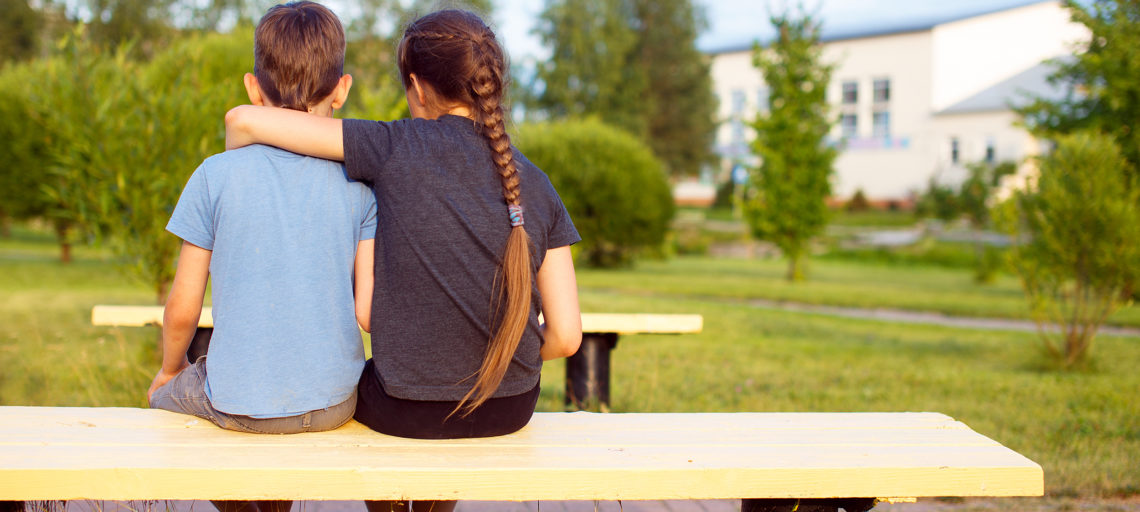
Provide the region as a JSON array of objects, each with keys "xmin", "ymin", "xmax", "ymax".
[{"xmin": 0, "ymin": 406, "xmax": 1043, "ymax": 512}]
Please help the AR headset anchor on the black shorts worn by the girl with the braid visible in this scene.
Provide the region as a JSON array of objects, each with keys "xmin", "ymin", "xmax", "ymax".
[{"xmin": 352, "ymin": 359, "xmax": 539, "ymax": 439}]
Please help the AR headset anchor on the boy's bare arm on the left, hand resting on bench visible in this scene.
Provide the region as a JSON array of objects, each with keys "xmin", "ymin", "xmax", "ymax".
[{"xmin": 146, "ymin": 242, "xmax": 212, "ymax": 400}]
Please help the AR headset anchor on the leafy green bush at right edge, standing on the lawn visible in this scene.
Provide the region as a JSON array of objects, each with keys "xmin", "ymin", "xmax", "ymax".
[{"xmin": 1002, "ymin": 132, "xmax": 1140, "ymax": 367}]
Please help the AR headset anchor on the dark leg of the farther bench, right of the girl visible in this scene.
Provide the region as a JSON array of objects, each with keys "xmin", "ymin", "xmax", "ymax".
[{"xmin": 565, "ymin": 333, "xmax": 618, "ymax": 413}]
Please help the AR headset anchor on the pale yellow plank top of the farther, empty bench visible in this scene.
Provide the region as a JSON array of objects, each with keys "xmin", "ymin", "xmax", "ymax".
[{"xmin": 91, "ymin": 306, "xmax": 703, "ymax": 334}]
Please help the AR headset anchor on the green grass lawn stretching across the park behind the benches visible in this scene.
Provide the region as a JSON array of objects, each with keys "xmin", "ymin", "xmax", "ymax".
[{"xmin": 0, "ymin": 225, "xmax": 1140, "ymax": 498}]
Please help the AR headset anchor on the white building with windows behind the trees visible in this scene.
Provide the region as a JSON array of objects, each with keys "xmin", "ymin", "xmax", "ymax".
[{"xmin": 711, "ymin": 0, "xmax": 1088, "ymax": 200}]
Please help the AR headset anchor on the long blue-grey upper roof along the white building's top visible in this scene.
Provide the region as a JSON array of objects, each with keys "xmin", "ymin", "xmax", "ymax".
[{"xmin": 707, "ymin": 0, "xmax": 1056, "ymax": 55}]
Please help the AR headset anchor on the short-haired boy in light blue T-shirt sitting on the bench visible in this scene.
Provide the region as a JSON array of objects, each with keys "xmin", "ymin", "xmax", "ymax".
[{"xmin": 147, "ymin": 1, "xmax": 376, "ymax": 433}]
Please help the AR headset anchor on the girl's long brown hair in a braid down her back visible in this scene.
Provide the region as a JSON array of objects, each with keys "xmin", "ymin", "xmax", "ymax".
[{"xmin": 397, "ymin": 10, "xmax": 532, "ymax": 416}]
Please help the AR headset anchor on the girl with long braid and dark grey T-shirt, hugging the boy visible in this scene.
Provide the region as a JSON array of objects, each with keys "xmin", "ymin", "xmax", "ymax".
[{"xmin": 226, "ymin": 5, "xmax": 581, "ymax": 462}]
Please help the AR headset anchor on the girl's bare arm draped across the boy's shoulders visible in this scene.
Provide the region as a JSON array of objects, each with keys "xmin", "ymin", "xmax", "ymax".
[{"xmin": 226, "ymin": 105, "xmax": 344, "ymax": 161}]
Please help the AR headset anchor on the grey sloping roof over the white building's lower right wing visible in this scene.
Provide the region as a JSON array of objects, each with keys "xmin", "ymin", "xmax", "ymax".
[{"xmin": 936, "ymin": 60, "xmax": 1066, "ymax": 115}]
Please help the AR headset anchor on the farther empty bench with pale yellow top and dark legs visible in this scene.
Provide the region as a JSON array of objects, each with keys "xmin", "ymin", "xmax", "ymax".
[{"xmin": 91, "ymin": 306, "xmax": 703, "ymax": 411}]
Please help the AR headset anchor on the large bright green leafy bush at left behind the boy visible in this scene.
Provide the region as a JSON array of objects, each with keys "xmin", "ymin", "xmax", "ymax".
[{"xmin": 0, "ymin": 10, "xmax": 406, "ymax": 302}]
